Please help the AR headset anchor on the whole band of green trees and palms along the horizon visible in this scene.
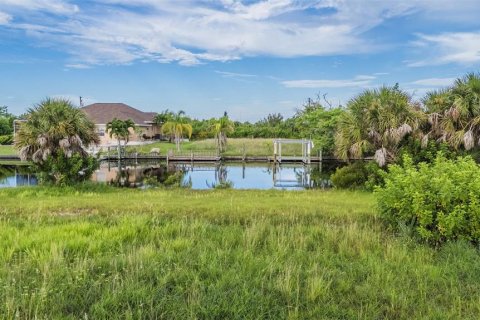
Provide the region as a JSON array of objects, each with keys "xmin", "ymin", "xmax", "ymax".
[{"xmin": 6, "ymin": 73, "xmax": 480, "ymax": 185}]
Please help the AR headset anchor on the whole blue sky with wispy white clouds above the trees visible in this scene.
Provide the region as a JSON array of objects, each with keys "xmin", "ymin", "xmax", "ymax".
[{"xmin": 0, "ymin": 0, "xmax": 480, "ymax": 121}]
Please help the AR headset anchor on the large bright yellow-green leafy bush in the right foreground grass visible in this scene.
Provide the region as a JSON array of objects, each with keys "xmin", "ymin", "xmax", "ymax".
[{"xmin": 375, "ymin": 153, "xmax": 480, "ymax": 244}]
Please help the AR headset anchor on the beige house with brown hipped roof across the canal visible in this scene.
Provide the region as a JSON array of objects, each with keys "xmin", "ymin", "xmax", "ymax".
[{"xmin": 81, "ymin": 103, "xmax": 160, "ymax": 145}]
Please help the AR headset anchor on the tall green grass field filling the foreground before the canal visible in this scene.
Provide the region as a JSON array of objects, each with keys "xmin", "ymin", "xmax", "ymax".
[{"xmin": 0, "ymin": 186, "xmax": 480, "ymax": 319}]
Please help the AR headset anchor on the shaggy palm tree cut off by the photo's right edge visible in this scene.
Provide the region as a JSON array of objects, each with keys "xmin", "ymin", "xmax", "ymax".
[{"xmin": 422, "ymin": 73, "xmax": 480, "ymax": 150}]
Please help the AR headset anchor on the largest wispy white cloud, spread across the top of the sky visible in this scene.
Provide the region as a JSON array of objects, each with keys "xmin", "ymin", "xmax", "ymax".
[{"xmin": 0, "ymin": 0, "xmax": 478, "ymax": 66}]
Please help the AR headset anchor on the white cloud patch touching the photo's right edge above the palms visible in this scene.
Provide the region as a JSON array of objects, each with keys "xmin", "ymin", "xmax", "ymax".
[{"xmin": 408, "ymin": 31, "xmax": 480, "ymax": 67}]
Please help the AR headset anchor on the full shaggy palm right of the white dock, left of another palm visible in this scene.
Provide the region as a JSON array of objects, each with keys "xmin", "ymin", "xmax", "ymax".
[{"xmin": 335, "ymin": 86, "xmax": 424, "ymax": 166}]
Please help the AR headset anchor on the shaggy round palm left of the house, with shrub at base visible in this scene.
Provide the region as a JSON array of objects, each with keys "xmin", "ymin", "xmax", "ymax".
[{"xmin": 15, "ymin": 98, "xmax": 99, "ymax": 184}]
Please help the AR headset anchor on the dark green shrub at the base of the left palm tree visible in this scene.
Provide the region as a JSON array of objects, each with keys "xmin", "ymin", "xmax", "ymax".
[{"xmin": 33, "ymin": 151, "xmax": 98, "ymax": 186}]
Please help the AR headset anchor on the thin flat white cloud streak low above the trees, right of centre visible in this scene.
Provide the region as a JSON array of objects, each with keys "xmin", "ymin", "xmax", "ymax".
[{"xmin": 281, "ymin": 76, "xmax": 375, "ymax": 88}]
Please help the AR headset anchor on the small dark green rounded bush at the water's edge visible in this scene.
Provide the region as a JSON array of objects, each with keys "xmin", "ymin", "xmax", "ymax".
[{"xmin": 330, "ymin": 161, "xmax": 383, "ymax": 191}]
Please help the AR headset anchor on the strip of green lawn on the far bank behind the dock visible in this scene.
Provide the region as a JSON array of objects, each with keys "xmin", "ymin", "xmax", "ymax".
[{"xmin": 129, "ymin": 138, "xmax": 318, "ymax": 156}]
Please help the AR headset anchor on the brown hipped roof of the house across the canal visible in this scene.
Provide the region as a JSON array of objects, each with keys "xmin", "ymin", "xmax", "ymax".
[{"xmin": 81, "ymin": 103, "xmax": 156, "ymax": 125}]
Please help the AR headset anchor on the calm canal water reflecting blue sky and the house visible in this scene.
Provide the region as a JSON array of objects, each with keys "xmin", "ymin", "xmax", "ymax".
[{"xmin": 0, "ymin": 162, "xmax": 339, "ymax": 190}]
